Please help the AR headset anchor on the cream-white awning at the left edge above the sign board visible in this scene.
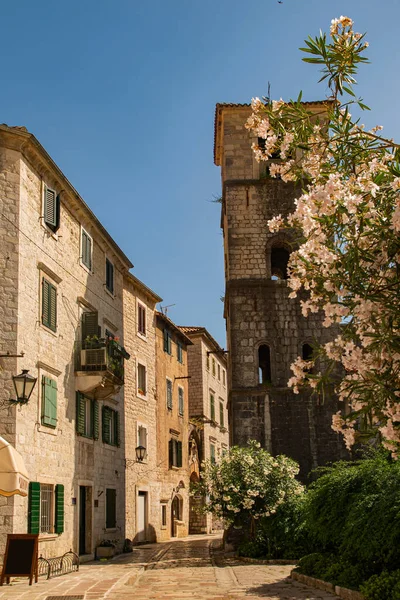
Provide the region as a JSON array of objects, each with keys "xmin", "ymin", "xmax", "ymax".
[{"xmin": 0, "ymin": 437, "xmax": 29, "ymax": 496}]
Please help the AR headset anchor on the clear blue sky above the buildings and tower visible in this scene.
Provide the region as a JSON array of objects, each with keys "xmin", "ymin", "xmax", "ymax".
[{"xmin": 0, "ymin": 0, "xmax": 400, "ymax": 346}]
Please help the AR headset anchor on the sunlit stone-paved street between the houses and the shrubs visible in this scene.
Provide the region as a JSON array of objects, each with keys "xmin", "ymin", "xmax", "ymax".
[{"xmin": 0, "ymin": 536, "xmax": 336, "ymax": 600}]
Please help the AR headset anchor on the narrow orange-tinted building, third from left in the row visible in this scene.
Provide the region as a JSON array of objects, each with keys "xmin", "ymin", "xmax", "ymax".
[{"xmin": 156, "ymin": 312, "xmax": 192, "ymax": 541}]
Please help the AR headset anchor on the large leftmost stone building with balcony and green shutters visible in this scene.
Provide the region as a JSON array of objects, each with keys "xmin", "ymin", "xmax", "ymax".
[{"xmin": 0, "ymin": 125, "xmax": 132, "ymax": 557}]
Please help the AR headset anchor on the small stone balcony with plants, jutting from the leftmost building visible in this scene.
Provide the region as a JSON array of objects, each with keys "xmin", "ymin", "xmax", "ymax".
[{"xmin": 75, "ymin": 337, "xmax": 130, "ymax": 400}]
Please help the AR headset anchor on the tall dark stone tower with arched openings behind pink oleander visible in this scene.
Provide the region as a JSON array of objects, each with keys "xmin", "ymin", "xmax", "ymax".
[{"xmin": 214, "ymin": 102, "xmax": 347, "ymax": 479}]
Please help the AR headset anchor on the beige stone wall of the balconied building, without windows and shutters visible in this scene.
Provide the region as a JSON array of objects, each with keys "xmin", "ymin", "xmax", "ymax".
[{"xmin": 0, "ymin": 131, "xmax": 127, "ymax": 556}]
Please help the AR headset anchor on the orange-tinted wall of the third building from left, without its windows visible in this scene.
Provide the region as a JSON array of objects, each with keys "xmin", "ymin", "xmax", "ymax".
[{"xmin": 156, "ymin": 317, "xmax": 189, "ymax": 540}]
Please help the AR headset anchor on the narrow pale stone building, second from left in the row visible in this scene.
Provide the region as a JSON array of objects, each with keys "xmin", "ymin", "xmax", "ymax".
[{"xmin": 123, "ymin": 273, "xmax": 162, "ymax": 543}]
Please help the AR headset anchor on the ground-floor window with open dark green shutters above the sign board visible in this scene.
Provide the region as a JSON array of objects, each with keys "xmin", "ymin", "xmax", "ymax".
[{"xmin": 28, "ymin": 481, "xmax": 64, "ymax": 533}]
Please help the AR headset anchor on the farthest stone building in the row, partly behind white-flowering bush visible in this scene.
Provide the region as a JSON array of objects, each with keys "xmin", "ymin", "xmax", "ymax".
[{"xmin": 180, "ymin": 326, "xmax": 229, "ymax": 533}]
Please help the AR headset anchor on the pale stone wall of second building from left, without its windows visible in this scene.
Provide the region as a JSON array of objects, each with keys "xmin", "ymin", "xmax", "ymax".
[{"xmin": 124, "ymin": 276, "xmax": 160, "ymax": 542}]
